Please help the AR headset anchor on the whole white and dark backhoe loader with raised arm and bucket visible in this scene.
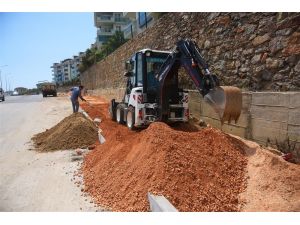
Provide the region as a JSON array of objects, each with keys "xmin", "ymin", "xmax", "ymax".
[{"xmin": 109, "ymin": 39, "xmax": 242, "ymax": 129}]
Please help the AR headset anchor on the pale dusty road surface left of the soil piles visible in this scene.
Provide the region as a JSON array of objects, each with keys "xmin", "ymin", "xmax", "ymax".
[{"xmin": 0, "ymin": 95, "xmax": 100, "ymax": 211}]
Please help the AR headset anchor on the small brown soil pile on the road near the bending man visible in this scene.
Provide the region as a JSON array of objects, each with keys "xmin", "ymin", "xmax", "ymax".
[{"xmin": 32, "ymin": 113, "xmax": 98, "ymax": 152}]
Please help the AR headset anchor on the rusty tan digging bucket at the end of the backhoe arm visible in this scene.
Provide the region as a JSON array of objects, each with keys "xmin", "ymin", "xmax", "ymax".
[{"xmin": 204, "ymin": 86, "xmax": 242, "ymax": 124}]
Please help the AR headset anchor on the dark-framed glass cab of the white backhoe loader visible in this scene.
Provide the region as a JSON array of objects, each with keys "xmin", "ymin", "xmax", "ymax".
[{"xmin": 124, "ymin": 49, "xmax": 170, "ymax": 102}]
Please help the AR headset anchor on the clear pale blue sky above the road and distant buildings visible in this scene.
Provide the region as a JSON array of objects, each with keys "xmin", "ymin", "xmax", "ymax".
[{"xmin": 0, "ymin": 12, "xmax": 96, "ymax": 89}]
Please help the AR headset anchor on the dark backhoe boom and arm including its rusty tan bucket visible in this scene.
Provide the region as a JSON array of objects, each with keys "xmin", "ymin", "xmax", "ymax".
[{"xmin": 157, "ymin": 39, "xmax": 242, "ymax": 123}]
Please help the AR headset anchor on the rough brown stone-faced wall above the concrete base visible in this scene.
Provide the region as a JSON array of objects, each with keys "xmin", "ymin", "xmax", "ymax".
[{"xmin": 81, "ymin": 13, "xmax": 300, "ymax": 91}]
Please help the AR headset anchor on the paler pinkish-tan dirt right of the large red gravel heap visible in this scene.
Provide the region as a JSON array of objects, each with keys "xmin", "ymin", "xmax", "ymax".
[{"xmin": 236, "ymin": 137, "xmax": 300, "ymax": 212}]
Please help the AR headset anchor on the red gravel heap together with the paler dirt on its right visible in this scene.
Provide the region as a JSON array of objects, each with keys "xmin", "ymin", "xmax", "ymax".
[{"xmin": 81, "ymin": 97, "xmax": 300, "ymax": 211}]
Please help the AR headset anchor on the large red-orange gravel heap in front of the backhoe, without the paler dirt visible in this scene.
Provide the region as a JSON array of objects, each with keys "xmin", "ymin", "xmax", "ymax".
[{"xmin": 82, "ymin": 98, "xmax": 247, "ymax": 211}]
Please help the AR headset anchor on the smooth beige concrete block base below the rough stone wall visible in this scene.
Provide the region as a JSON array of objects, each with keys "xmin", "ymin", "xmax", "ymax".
[{"xmin": 89, "ymin": 88, "xmax": 300, "ymax": 154}]
